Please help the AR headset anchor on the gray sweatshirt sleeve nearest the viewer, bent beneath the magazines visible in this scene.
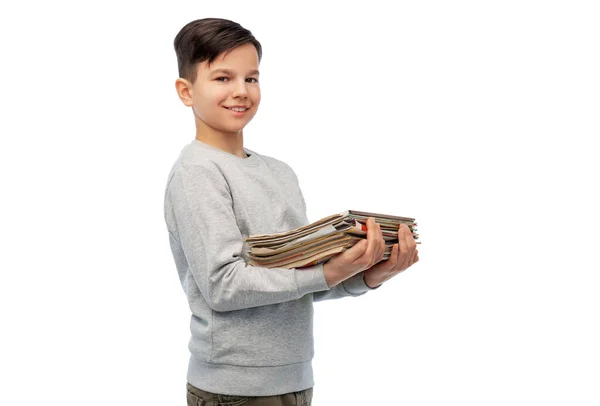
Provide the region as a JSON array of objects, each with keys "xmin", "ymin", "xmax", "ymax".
[{"xmin": 166, "ymin": 164, "xmax": 329, "ymax": 311}]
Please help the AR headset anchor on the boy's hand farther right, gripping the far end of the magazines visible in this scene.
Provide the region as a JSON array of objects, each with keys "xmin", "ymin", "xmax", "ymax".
[{"xmin": 364, "ymin": 224, "xmax": 419, "ymax": 288}]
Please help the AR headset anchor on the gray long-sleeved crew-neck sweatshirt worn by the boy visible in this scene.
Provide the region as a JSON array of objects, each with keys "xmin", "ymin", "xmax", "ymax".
[{"xmin": 164, "ymin": 140, "xmax": 370, "ymax": 396}]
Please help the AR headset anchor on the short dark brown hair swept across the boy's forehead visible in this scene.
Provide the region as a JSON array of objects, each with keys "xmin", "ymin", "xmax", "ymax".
[{"xmin": 173, "ymin": 18, "xmax": 262, "ymax": 83}]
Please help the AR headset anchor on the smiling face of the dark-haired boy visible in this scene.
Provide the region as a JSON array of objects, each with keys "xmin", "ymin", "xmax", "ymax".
[{"xmin": 190, "ymin": 44, "xmax": 260, "ymax": 134}]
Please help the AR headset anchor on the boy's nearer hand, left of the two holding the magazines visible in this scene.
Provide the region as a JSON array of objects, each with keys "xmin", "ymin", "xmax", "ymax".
[{"xmin": 323, "ymin": 217, "xmax": 385, "ymax": 288}]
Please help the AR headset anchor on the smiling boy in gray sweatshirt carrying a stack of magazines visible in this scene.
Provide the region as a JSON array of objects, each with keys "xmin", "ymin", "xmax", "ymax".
[{"xmin": 164, "ymin": 18, "xmax": 418, "ymax": 406}]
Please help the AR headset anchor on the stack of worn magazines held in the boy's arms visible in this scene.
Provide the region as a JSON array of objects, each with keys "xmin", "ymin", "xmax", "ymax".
[{"xmin": 246, "ymin": 210, "xmax": 419, "ymax": 269}]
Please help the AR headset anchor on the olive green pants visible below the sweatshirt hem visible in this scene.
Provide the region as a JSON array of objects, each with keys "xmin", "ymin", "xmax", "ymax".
[{"xmin": 187, "ymin": 383, "xmax": 313, "ymax": 406}]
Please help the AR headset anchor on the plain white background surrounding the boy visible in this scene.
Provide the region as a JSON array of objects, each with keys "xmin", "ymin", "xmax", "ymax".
[{"xmin": 0, "ymin": 0, "xmax": 600, "ymax": 406}]
